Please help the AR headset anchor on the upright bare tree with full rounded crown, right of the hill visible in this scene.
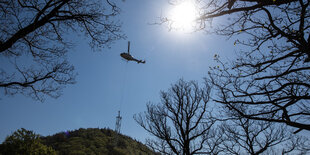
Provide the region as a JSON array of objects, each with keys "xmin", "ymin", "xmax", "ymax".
[{"xmin": 134, "ymin": 80, "xmax": 220, "ymax": 155}]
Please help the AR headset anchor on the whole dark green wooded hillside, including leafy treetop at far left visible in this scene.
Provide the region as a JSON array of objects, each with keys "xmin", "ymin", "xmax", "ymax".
[{"xmin": 0, "ymin": 128, "xmax": 156, "ymax": 155}]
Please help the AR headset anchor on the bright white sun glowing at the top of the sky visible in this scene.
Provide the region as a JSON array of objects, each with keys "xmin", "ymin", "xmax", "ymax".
[{"xmin": 170, "ymin": 0, "xmax": 198, "ymax": 32}]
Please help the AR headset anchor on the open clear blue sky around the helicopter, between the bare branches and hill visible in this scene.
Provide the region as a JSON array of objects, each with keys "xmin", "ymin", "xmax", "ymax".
[{"xmin": 0, "ymin": 0, "xmax": 236, "ymax": 142}]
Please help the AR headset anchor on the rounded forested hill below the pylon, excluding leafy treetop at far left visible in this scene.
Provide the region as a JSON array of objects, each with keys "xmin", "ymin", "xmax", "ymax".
[{"xmin": 41, "ymin": 128, "xmax": 155, "ymax": 155}]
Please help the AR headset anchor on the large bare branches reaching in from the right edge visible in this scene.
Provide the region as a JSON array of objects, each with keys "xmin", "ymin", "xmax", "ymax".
[{"xmin": 161, "ymin": 0, "xmax": 310, "ymax": 132}]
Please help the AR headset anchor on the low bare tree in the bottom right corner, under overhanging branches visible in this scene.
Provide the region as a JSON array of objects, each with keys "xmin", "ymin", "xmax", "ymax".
[{"xmin": 219, "ymin": 111, "xmax": 309, "ymax": 155}]
